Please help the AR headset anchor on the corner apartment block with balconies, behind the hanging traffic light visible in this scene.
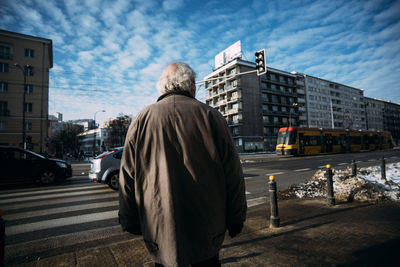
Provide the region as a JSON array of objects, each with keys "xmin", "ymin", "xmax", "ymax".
[{"xmin": 204, "ymin": 58, "xmax": 298, "ymax": 152}]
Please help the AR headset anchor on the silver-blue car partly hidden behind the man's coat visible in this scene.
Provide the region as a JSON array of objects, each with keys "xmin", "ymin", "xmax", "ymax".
[{"xmin": 89, "ymin": 147, "xmax": 124, "ymax": 190}]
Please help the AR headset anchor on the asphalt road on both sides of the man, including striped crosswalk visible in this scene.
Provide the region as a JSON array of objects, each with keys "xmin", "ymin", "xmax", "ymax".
[{"xmin": 0, "ymin": 150, "xmax": 400, "ymax": 265}]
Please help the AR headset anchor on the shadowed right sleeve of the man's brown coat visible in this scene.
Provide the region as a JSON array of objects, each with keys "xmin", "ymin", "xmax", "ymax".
[{"xmin": 219, "ymin": 112, "xmax": 247, "ymax": 227}]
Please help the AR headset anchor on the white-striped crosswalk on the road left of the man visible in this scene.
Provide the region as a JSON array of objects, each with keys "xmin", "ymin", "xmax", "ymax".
[{"xmin": 0, "ymin": 182, "xmax": 136, "ymax": 265}]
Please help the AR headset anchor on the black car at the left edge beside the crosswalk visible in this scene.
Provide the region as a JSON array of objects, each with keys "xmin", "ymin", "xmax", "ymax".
[{"xmin": 0, "ymin": 146, "xmax": 72, "ymax": 184}]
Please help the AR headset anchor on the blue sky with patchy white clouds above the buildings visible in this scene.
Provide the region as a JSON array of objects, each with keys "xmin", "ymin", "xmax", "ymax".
[{"xmin": 0, "ymin": 0, "xmax": 400, "ymax": 125}]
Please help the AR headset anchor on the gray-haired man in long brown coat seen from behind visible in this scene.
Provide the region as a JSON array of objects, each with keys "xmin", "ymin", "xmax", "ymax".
[{"xmin": 119, "ymin": 62, "xmax": 247, "ymax": 266}]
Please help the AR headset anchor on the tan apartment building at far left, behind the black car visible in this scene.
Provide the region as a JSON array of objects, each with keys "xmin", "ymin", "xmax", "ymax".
[{"xmin": 0, "ymin": 30, "xmax": 53, "ymax": 152}]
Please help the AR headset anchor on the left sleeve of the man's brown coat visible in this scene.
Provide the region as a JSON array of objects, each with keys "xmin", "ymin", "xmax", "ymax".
[{"xmin": 118, "ymin": 124, "xmax": 141, "ymax": 235}]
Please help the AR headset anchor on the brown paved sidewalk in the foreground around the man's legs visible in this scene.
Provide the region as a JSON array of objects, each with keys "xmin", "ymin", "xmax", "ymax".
[{"xmin": 13, "ymin": 199, "xmax": 400, "ymax": 266}]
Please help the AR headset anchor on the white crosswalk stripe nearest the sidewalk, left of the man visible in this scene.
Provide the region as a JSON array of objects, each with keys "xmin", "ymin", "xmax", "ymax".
[{"xmin": 6, "ymin": 210, "xmax": 118, "ymax": 236}]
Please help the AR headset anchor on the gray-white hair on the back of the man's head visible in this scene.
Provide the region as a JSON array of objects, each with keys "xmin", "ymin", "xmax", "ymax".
[{"xmin": 156, "ymin": 62, "xmax": 196, "ymax": 95}]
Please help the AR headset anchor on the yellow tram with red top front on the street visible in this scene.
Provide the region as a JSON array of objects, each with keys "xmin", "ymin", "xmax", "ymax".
[{"xmin": 276, "ymin": 127, "xmax": 393, "ymax": 156}]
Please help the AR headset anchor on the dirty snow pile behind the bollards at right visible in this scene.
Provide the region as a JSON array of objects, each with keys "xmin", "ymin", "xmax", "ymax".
[{"xmin": 279, "ymin": 162, "xmax": 400, "ymax": 202}]
